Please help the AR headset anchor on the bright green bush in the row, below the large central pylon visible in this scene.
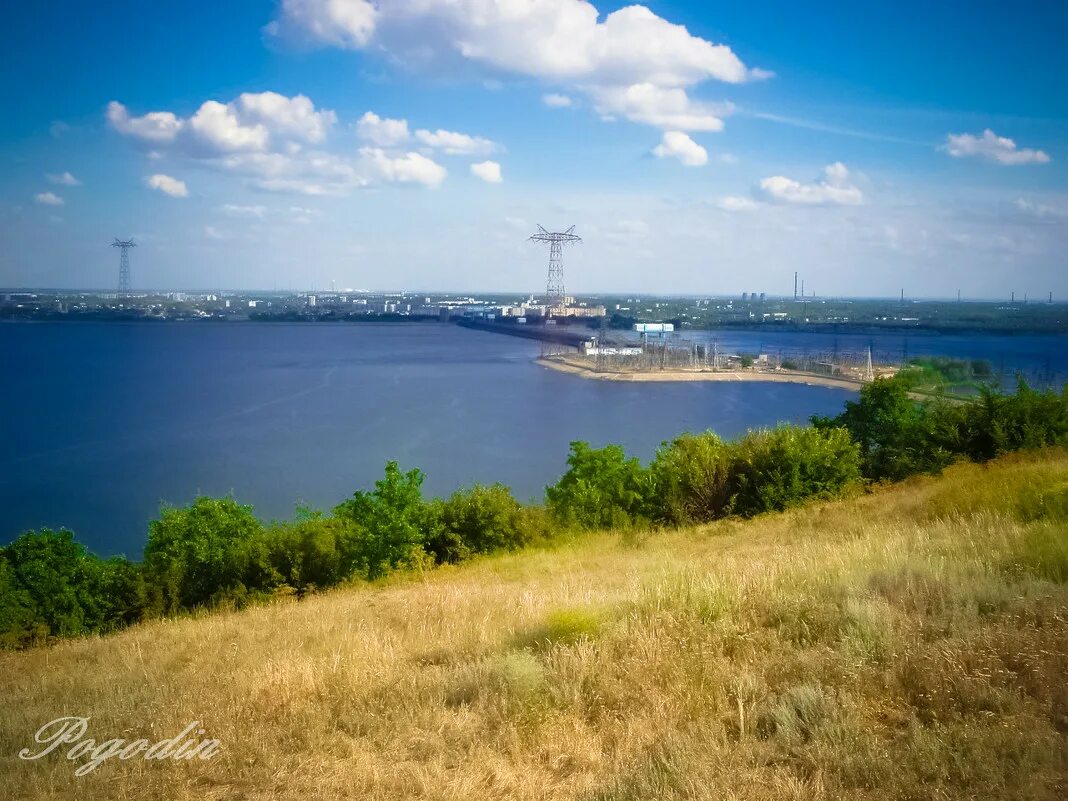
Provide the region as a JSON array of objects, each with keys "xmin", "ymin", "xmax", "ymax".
[{"xmin": 545, "ymin": 441, "xmax": 650, "ymax": 529}]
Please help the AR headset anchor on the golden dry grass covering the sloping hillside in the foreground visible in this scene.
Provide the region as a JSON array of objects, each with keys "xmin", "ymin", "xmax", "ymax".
[{"xmin": 0, "ymin": 452, "xmax": 1068, "ymax": 801}]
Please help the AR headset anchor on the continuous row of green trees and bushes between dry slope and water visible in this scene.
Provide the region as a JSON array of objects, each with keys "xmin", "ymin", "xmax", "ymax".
[{"xmin": 0, "ymin": 378, "xmax": 1068, "ymax": 648}]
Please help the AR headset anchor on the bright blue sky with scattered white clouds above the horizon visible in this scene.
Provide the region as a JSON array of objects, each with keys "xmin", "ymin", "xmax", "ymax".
[{"xmin": 0, "ymin": 0, "xmax": 1068, "ymax": 298}]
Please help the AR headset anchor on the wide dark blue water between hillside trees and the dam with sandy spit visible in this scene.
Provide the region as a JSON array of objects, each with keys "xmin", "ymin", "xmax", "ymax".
[{"xmin": 0, "ymin": 323, "xmax": 1063, "ymax": 556}]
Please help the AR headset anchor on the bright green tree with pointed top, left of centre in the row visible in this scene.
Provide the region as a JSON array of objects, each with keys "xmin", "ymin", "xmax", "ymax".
[{"xmin": 334, "ymin": 461, "xmax": 429, "ymax": 580}]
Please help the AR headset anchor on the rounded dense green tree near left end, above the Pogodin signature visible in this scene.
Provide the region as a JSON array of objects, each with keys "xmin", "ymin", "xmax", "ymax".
[{"xmin": 144, "ymin": 498, "xmax": 267, "ymax": 613}]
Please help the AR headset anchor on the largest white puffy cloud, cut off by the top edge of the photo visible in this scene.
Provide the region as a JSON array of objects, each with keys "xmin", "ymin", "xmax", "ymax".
[{"xmin": 267, "ymin": 0, "xmax": 770, "ymax": 130}]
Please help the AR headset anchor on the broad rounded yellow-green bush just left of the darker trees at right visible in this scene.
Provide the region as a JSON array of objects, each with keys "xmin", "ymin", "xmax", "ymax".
[{"xmin": 728, "ymin": 425, "xmax": 861, "ymax": 516}]
